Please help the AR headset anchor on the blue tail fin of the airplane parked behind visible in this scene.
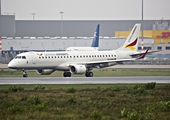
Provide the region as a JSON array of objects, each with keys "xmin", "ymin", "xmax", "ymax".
[{"xmin": 91, "ymin": 24, "xmax": 100, "ymax": 47}]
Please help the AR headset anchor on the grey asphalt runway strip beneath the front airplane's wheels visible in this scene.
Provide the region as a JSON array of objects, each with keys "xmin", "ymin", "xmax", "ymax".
[{"xmin": 0, "ymin": 76, "xmax": 170, "ymax": 84}]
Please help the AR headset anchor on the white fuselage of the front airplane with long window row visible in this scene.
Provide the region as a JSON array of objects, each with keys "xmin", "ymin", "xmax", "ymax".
[{"xmin": 8, "ymin": 51, "xmax": 132, "ymax": 71}]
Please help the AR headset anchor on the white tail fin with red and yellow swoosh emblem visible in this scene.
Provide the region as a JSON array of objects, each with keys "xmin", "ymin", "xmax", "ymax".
[{"xmin": 118, "ymin": 24, "xmax": 141, "ymax": 51}]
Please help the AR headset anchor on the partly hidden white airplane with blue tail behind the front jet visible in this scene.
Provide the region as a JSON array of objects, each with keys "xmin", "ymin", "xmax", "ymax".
[{"xmin": 66, "ymin": 24, "xmax": 100, "ymax": 51}]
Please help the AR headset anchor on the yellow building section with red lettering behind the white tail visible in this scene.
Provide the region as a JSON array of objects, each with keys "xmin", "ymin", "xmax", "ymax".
[{"xmin": 115, "ymin": 30, "xmax": 170, "ymax": 44}]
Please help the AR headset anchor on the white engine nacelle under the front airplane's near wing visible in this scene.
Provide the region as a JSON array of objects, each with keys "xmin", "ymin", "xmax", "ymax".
[{"xmin": 70, "ymin": 65, "xmax": 87, "ymax": 74}]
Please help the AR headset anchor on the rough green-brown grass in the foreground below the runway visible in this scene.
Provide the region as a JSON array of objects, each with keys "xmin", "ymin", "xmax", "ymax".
[{"xmin": 0, "ymin": 82, "xmax": 170, "ymax": 120}]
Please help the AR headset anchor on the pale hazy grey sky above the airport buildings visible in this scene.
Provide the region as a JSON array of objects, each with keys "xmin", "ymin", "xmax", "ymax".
[{"xmin": 1, "ymin": 0, "xmax": 170, "ymax": 20}]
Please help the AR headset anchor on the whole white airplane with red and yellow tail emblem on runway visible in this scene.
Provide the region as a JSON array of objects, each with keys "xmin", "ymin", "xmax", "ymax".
[{"xmin": 8, "ymin": 24, "xmax": 148, "ymax": 77}]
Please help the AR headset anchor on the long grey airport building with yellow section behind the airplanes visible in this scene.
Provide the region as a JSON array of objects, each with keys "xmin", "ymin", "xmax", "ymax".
[{"xmin": 0, "ymin": 13, "xmax": 170, "ymax": 63}]
